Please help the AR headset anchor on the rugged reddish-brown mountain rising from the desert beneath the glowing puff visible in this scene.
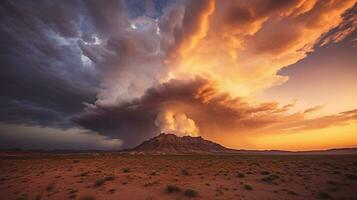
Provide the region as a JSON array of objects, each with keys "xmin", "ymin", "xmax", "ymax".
[{"xmin": 129, "ymin": 133, "xmax": 235, "ymax": 154}]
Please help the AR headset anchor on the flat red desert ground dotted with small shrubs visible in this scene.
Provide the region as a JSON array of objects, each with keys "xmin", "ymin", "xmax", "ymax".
[{"xmin": 0, "ymin": 154, "xmax": 357, "ymax": 200}]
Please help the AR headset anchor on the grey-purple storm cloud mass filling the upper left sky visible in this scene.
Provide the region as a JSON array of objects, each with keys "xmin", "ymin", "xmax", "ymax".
[{"xmin": 0, "ymin": 1, "xmax": 160, "ymax": 133}]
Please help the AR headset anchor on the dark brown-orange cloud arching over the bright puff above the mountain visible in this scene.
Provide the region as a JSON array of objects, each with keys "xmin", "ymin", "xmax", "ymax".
[{"xmin": 74, "ymin": 77, "xmax": 296, "ymax": 147}]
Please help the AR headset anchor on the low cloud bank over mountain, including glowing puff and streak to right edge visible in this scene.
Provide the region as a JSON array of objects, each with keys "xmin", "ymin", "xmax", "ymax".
[{"xmin": 74, "ymin": 77, "xmax": 355, "ymax": 146}]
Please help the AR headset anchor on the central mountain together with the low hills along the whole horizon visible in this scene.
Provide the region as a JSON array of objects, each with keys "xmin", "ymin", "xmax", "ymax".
[{"xmin": 0, "ymin": 133, "xmax": 357, "ymax": 157}]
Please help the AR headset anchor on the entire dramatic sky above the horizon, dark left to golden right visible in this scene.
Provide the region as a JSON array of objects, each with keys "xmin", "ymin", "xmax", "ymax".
[{"xmin": 0, "ymin": 0, "xmax": 357, "ymax": 150}]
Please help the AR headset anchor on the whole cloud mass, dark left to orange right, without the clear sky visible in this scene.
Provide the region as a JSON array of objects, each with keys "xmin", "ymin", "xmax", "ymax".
[{"xmin": 0, "ymin": 0, "xmax": 356, "ymax": 148}]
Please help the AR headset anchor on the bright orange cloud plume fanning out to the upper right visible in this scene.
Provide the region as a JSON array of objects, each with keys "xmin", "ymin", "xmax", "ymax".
[{"xmin": 163, "ymin": 0, "xmax": 355, "ymax": 96}]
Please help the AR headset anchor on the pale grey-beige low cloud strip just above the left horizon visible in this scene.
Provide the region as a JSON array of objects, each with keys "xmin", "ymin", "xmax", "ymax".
[{"xmin": 0, "ymin": 123, "xmax": 122, "ymax": 150}]
